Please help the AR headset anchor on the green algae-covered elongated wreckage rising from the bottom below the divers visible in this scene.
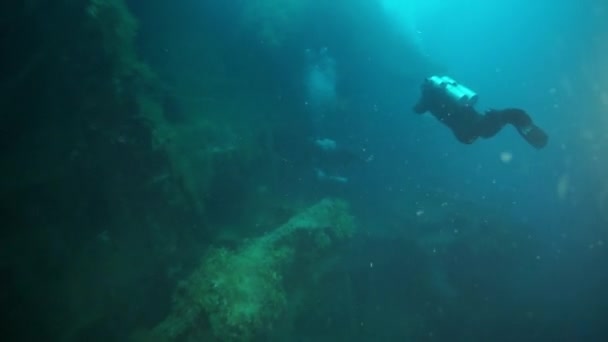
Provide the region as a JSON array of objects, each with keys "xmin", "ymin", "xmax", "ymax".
[{"xmin": 147, "ymin": 199, "xmax": 355, "ymax": 341}]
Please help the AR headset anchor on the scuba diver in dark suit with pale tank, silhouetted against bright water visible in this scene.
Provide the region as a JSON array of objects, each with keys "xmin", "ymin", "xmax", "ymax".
[{"xmin": 414, "ymin": 76, "xmax": 549, "ymax": 149}]
